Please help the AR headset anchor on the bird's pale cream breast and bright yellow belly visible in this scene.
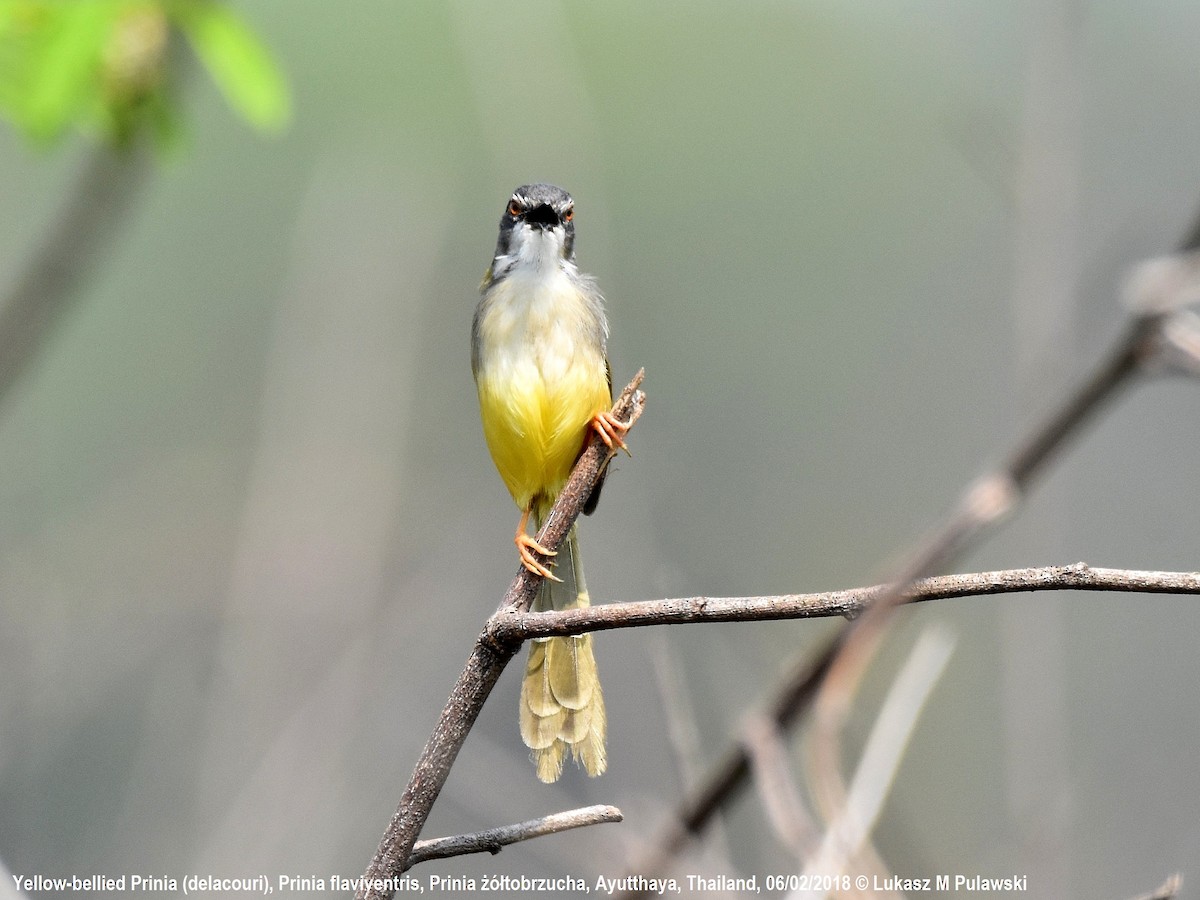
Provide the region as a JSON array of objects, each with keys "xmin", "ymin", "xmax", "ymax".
[{"xmin": 475, "ymin": 273, "xmax": 612, "ymax": 515}]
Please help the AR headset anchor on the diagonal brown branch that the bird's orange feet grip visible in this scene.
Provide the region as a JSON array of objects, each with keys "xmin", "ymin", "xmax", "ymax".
[{"xmin": 355, "ymin": 370, "xmax": 646, "ymax": 900}]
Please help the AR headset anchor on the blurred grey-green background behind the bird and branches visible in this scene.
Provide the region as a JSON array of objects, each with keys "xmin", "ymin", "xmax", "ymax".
[{"xmin": 0, "ymin": 0, "xmax": 1200, "ymax": 898}]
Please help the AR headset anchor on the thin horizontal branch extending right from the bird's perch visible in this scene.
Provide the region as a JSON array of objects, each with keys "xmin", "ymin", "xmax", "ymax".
[{"xmin": 488, "ymin": 563, "xmax": 1200, "ymax": 644}]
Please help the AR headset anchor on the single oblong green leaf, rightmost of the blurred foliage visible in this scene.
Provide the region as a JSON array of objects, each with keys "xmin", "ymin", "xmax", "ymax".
[{"xmin": 170, "ymin": 0, "xmax": 292, "ymax": 131}]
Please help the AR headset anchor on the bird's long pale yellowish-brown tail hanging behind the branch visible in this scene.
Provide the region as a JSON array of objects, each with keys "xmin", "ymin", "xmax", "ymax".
[{"xmin": 521, "ymin": 526, "xmax": 608, "ymax": 784}]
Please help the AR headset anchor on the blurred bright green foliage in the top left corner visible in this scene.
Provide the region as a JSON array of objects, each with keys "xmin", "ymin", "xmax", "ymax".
[{"xmin": 0, "ymin": 0, "xmax": 290, "ymax": 149}]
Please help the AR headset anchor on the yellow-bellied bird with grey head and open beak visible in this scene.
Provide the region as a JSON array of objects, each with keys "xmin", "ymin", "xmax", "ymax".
[{"xmin": 470, "ymin": 184, "xmax": 629, "ymax": 784}]
